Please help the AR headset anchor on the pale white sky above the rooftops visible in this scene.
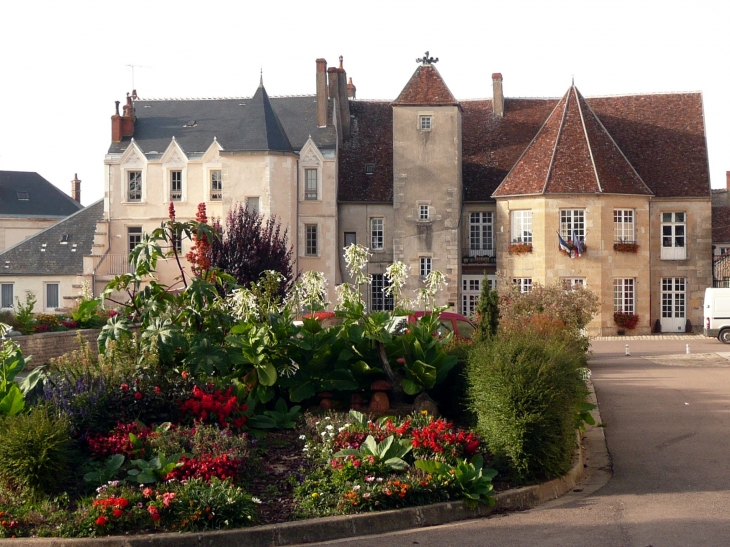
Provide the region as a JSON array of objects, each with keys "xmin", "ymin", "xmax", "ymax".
[{"xmin": 0, "ymin": 0, "xmax": 730, "ymax": 205}]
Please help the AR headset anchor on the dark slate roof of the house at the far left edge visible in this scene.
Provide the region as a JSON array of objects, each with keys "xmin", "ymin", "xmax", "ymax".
[{"xmin": 0, "ymin": 171, "xmax": 82, "ymax": 218}]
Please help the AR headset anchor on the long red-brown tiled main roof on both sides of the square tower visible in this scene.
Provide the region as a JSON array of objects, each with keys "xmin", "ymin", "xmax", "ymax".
[{"xmin": 338, "ymin": 89, "xmax": 710, "ymax": 202}]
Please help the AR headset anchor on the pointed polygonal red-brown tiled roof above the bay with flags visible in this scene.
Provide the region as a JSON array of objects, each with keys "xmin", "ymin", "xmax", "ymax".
[{"xmin": 493, "ymin": 86, "xmax": 651, "ymax": 197}]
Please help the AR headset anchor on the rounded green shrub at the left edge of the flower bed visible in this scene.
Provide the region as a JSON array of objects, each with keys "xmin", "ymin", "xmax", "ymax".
[{"xmin": 0, "ymin": 406, "xmax": 76, "ymax": 495}]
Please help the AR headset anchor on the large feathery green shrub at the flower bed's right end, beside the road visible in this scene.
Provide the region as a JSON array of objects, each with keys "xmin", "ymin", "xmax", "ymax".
[{"xmin": 468, "ymin": 325, "xmax": 586, "ymax": 482}]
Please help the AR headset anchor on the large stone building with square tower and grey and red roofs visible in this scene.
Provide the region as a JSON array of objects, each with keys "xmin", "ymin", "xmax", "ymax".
[{"xmin": 97, "ymin": 54, "xmax": 712, "ymax": 334}]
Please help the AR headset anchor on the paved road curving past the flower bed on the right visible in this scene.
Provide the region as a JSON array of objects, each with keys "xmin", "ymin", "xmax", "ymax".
[{"xmin": 294, "ymin": 339, "xmax": 730, "ymax": 547}]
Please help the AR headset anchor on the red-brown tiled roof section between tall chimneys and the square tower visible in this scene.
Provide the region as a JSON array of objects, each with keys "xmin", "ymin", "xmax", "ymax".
[{"xmin": 337, "ymin": 101, "xmax": 393, "ymax": 202}]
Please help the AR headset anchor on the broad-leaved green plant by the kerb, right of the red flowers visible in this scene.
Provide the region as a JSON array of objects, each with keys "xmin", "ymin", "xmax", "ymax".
[{"xmin": 414, "ymin": 454, "xmax": 497, "ymax": 507}]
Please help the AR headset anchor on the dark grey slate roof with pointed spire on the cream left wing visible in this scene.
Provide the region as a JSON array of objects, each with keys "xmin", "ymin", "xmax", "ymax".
[{"xmin": 109, "ymin": 86, "xmax": 337, "ymax": 154}]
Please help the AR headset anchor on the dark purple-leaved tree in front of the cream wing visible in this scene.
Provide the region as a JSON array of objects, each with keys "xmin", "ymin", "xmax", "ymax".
[{"xmin": 209, "ymin": 203, "xmax": 293, "ymax": 291}]
